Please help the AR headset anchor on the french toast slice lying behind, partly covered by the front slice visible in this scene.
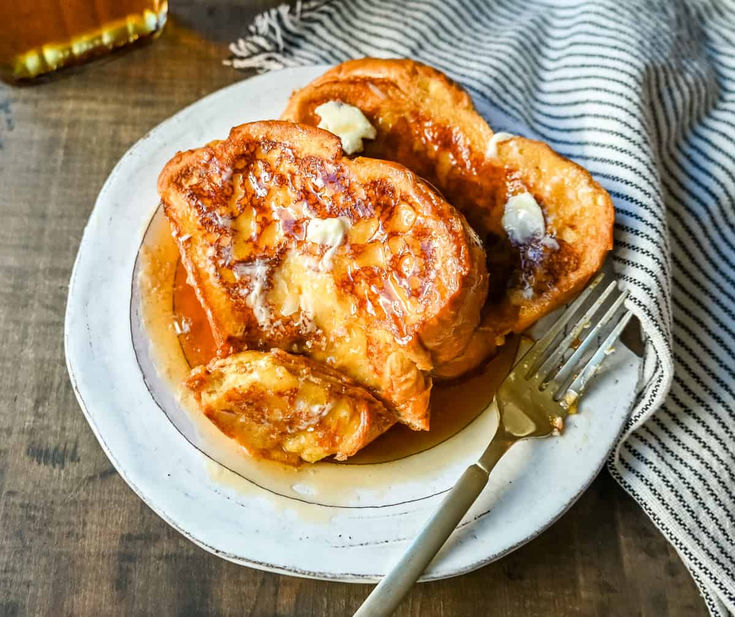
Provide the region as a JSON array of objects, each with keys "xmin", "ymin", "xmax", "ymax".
[{"xmin": 282, "ymin": 58, "xmax": 614, "ymax": 377}]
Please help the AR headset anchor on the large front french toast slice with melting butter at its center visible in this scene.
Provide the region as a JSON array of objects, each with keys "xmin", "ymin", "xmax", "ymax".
[{"xmin": 158, "ymin": 121, "xmax": 487, "ymax": 429}]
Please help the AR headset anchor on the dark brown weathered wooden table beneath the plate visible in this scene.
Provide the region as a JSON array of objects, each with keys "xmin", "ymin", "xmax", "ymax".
[{"xmin": 0, "ymin": 0, "xmax": 706, "ymax": 617}]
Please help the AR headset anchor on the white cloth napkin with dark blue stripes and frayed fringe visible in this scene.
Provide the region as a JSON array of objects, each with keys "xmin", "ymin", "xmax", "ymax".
[{"xmin": 231, "ymin": 0, "xmax": 735, "ymax": 615}]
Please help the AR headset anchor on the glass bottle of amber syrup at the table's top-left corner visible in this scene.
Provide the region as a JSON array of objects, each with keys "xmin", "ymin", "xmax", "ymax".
[{"xmin": 0, "ymin": 0, "xmax": 168, "ymax": 82}]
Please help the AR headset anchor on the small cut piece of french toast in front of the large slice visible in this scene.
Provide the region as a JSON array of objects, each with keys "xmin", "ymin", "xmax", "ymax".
[{"xmin": 190, "ymin": 349, "xmax": 395, "ymax": 465}]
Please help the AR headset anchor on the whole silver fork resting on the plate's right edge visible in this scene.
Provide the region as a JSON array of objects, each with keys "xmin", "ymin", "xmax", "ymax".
[{"xmin": 354, "ymin": 272, "xmax": 632, "ymax": 617}]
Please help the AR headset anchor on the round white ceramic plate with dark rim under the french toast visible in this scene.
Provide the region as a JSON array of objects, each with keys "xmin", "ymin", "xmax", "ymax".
[{"xmin": 65, "ymin": 67, "xmax": 639, "ymax": 582}]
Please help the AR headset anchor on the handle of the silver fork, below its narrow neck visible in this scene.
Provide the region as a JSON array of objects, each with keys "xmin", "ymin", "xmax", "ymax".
[{"xmin": 354, "ymin": 457, "xmax": 492, "ymax": 617}]
